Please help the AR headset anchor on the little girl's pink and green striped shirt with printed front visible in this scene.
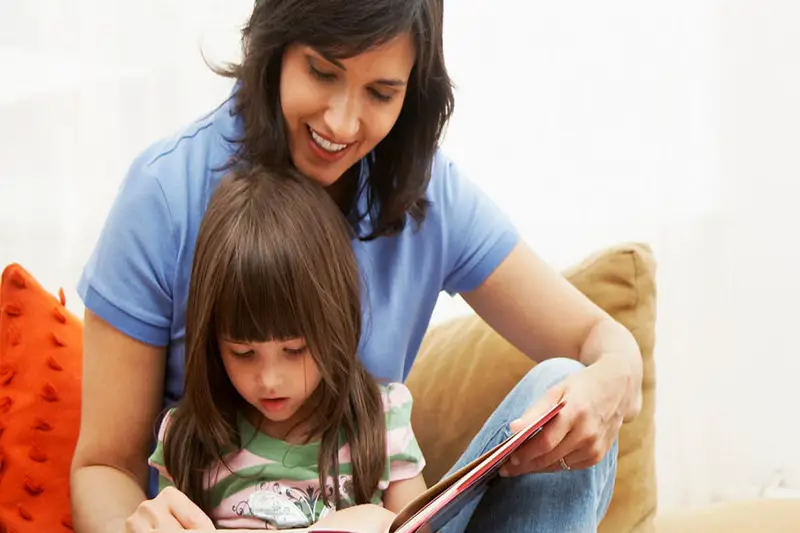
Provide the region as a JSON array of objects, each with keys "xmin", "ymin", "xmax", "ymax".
[{"xmin": 150, "ymin": 383, "xmax": 425, "ymax": 529}]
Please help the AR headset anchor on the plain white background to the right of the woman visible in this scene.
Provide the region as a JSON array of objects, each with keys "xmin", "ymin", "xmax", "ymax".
[{"xmin": 436, "ymin": 0, "xmax": 800, "ymax": 508}]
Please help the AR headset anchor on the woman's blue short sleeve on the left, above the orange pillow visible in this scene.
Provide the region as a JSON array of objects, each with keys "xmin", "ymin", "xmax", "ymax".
[{"xmin": 78, "ymin": 157, "xmax": 178, "ymax": 346}]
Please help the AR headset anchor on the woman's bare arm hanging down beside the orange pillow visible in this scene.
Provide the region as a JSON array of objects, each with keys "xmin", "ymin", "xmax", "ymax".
[{"xmin": 70, "ymin": 310, "xmax": 213, "ymax": 533}]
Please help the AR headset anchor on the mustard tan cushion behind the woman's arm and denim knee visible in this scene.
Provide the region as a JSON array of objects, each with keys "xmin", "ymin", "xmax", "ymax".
[{"xmin": 407, "ymin": 243, "xmax": 656, "ymax": 533}]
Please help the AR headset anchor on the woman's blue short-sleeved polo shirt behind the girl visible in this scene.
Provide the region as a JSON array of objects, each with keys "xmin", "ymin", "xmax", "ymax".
[{"xmin": 78, "ymin": 90, "xmax": 518, "ymax": 494}]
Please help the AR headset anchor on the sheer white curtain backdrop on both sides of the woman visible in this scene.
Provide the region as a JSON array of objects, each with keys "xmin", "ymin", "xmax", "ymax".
[{"xmin": 0, "ymin": 0, "xmax": 800, "ymax": 507}]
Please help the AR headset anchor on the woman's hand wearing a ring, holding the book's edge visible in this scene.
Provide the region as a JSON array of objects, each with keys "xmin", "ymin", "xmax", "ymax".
[{"xmin": 501, "ymin": 357, "xmax": 641, "ymax": 476}]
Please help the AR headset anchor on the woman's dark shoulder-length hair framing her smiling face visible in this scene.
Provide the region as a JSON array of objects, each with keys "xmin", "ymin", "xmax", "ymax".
[{"xmin": 217, "ymin": 0, "xmax": 453, "ymax": 240}]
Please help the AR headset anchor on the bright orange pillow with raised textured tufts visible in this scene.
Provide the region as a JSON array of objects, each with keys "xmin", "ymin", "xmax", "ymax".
[{"xmin": 0, "ymin": 264, "xmax": 83, "ymax": 533}]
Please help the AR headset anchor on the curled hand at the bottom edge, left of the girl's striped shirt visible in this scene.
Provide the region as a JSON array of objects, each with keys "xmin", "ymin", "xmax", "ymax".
[{"xmin": 123, "ymin": 487, "xmax": 216, "ymax": 533}]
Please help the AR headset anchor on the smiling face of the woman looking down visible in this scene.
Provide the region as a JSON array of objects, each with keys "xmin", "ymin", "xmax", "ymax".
[{"xmin": 280, "ymin": 34, "xmax": 414, "ymax": 187}]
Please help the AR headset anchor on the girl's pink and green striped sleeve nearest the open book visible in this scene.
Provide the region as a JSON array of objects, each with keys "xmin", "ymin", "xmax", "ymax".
[{"xmin": 382, "ymin": 383, "xmax": 425, "ymax": 488}]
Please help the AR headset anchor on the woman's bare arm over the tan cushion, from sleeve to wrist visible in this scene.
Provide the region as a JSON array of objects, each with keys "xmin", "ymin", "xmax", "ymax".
[{"xmin": 462, "ymin": 241, "xmax": 642, "ymax": 420}]
